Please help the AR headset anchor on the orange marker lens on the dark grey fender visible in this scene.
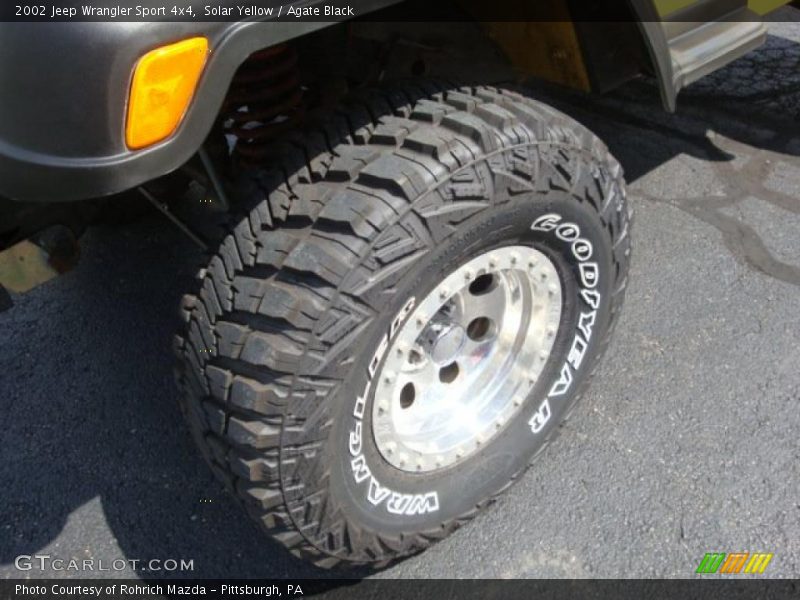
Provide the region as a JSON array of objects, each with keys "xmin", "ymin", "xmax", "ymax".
[{"xmin": 125, "ymin": 37, "xmax": 208, "ymax": 149}]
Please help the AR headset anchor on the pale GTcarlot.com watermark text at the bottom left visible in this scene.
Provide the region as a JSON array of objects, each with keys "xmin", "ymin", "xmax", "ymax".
[{"xmin": 14, "ymin": 554, "xmax": 194, "ymax": 573}]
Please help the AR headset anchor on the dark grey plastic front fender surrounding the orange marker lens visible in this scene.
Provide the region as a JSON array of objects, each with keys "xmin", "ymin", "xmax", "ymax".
[{"xmin": 0, "ymin": 0, "xmax": 397, "ymax": 202}]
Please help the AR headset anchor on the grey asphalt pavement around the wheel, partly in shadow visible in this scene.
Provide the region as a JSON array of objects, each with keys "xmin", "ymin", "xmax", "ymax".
[{"xmin": 0, "ymin": 15, "xmax": 800, "ymax": 578}]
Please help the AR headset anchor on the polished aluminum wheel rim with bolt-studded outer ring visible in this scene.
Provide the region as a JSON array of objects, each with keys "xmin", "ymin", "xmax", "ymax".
[{"xmin": 372, "ymin": 246, "xmax": 562, "ymax": 472}]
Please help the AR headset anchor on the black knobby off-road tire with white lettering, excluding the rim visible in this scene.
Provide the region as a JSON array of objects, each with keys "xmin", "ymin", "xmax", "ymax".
[{"xmin": 176, "ymin": 82, "xmax": 631, "ymax": 567}]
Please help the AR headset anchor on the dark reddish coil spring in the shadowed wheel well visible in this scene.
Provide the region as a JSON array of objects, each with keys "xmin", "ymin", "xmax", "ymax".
[{"xmin": 222, "ymin": 44, "xmax": 303, "ymax": 165}]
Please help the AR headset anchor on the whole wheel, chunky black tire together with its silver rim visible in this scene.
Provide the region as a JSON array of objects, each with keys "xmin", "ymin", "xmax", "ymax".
[{"xmin": 177, "ymin": 82, "xmax": 630, "ymax": 567}]
